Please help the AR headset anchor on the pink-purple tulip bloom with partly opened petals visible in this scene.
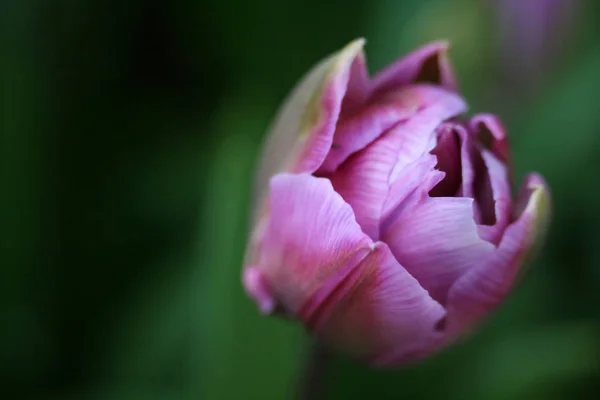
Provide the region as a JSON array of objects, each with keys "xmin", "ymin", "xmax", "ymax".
[{"xmin": 243, "ymin": 40, "xmax": 549, "ymax": 365}]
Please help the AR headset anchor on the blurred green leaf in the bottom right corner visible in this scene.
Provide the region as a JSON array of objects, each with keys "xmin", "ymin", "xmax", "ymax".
[{"xmin": 456, "ymin": 323, "xmax": 600, "ymax": 399}]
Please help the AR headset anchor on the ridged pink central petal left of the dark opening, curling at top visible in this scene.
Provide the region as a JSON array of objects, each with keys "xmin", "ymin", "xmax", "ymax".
[{"xmin": 331, "ymin": 86, "xmax": 465, "ymax": 240}]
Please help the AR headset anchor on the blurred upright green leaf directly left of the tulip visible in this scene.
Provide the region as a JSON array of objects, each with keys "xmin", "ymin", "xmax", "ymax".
[{"xmin": 192, "ymin": 88, "xmax": 303, "ymax": 400}]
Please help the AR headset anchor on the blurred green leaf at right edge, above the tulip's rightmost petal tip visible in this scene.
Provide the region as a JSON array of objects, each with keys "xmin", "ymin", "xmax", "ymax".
[{"xmin": 511, "ymin": 49, "xmax": 600, "ymax": 187}]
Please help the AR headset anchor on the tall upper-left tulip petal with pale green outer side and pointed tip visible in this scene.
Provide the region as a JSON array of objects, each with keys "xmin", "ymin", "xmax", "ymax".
[{"xmin": 252, "ymin": 39, "xmax": 367, "ymax": 208}]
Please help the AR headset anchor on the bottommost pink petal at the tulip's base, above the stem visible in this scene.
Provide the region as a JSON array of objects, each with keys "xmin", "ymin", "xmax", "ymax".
[{"xmin": 307, "ymin": 242, "xmax": 445, "ymax": 365}]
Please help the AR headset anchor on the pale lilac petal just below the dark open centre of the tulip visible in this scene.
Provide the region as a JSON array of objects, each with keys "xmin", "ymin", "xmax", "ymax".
[{"xmin": 381, "ymin": 186, "xmax": 494, "ymax": 304}]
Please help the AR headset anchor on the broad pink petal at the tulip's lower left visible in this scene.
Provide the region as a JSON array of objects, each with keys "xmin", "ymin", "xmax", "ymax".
[{"xmin": 245, "ymin": 174, "xmax": 372, "ymax": 314}]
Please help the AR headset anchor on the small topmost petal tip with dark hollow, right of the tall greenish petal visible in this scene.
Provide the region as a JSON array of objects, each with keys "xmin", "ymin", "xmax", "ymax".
[{"xmin": 371, "ymin": 41, "xmax": 456, "ymax": 98}]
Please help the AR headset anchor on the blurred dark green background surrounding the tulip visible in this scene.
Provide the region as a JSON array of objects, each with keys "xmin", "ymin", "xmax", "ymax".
[{"xmin": 0, "ymin": 0, "xmax": 600, "ymax": 400}]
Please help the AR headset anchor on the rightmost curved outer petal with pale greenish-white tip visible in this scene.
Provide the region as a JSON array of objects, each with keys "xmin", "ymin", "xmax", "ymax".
[{"xmin": 447, "ymin": 174, "xmax": 550, "ymax": 339}]
